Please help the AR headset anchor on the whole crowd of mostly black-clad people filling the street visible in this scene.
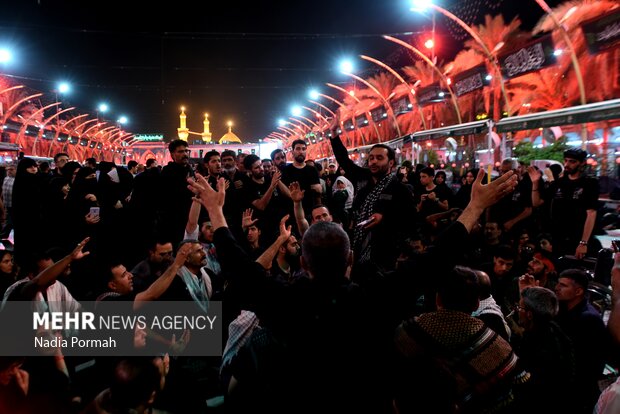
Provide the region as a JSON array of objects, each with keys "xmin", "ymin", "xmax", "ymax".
[{"xmin": 0, "ymin": 121, "xmax": 620, "ymax": 414}]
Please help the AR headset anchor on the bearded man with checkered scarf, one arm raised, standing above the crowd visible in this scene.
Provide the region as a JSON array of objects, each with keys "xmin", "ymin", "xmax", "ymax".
[{"xmin": 330, "ymin": 119, "xmax": 416, "ymax": 269}]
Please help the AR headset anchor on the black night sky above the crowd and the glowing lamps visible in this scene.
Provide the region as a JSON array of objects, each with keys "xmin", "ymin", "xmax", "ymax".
[{"xmin": 0, "ymin": 0, "xmax": 559, "ymax": 141}]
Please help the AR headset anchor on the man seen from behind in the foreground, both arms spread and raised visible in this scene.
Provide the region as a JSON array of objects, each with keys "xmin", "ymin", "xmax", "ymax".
[{"xmin": 188, "ymin": 170, "xmax": 516, "ymax": 413}]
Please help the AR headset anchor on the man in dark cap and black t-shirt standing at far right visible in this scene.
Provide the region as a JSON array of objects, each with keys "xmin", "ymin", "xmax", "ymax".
[{"xmin": 527, "ymin": 148, "xmax": 599, "ymax": 259}]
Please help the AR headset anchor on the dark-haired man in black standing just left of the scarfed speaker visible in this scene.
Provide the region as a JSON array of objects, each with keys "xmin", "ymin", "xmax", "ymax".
[{"xmin": 282, "ymin": 139, "xmax": 322, "ymax": 215}]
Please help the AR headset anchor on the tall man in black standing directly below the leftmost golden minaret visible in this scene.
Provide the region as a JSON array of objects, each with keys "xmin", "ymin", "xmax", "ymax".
[{"xmin": 160, "ymin": 139, "xmax": 194, "ymax": 246}]
